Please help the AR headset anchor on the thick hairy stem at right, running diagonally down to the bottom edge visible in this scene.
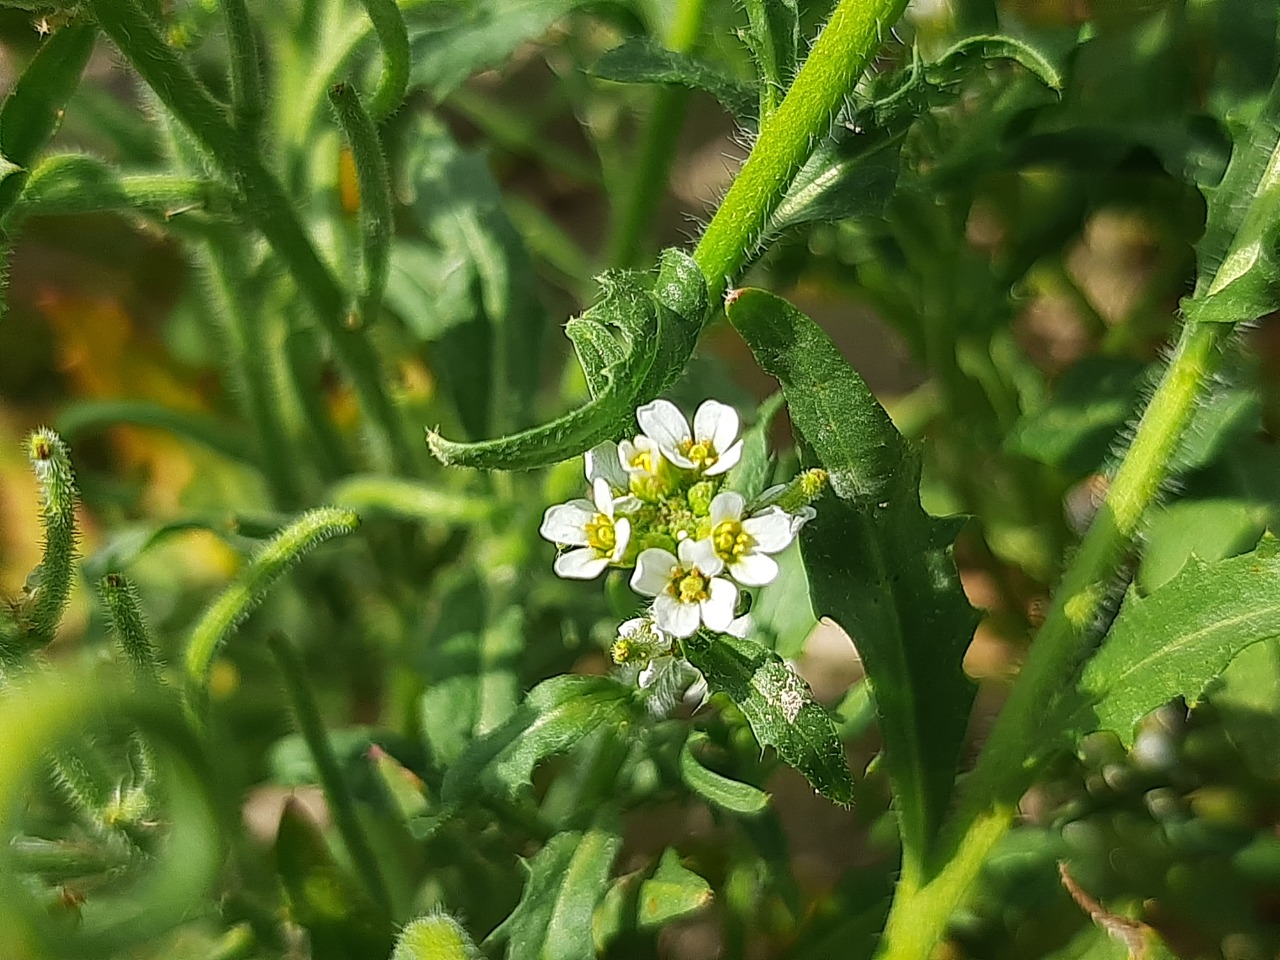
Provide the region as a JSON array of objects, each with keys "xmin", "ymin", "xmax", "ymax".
[{"xmin": 879, "ymin": 324, "xmax": 1233, "ymax": 960}]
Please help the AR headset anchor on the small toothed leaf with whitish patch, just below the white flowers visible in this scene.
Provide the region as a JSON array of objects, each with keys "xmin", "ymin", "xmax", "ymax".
[{"xmin": 685, "ymin": 635, "xmax": 854, "ymax": 805}]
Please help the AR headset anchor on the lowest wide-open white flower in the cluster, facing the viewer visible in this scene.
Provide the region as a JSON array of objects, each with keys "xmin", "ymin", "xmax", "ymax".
[{"xmin": 631, "ymin": 540, "xmax": 737, "ymax": 637}]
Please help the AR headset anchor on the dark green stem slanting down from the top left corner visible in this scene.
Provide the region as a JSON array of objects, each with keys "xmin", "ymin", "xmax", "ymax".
[{"xmin": 90, "ymin": 0, "xmax": 417, "ymax": 474}]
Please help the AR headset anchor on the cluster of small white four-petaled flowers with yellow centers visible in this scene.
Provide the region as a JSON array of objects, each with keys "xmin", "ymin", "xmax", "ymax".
[{"xmin": 540, "ymin": 399, "xmax": 826, "ymax": 706}]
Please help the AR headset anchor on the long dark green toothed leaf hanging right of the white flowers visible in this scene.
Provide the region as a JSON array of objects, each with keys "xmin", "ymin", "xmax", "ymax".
[{"xmin": 727, "ymin": 289, "xmax": 978, "ymax": 856}]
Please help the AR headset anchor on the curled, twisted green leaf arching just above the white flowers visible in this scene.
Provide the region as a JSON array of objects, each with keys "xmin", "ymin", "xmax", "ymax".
[{"xmin": 426, "ymin": 250, "xmax": 710, "ymax": 470}]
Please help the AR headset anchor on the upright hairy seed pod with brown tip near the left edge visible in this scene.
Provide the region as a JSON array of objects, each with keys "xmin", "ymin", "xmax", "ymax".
[{"xmin": 20, "ymin": 428, "xmax": 77, "ymax": 646}]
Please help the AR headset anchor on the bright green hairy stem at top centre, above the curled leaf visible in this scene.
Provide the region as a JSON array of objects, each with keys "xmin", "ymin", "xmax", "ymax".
[{"xmin": 694, "ymin": 0, "xmax": 906, "ymax": 301}]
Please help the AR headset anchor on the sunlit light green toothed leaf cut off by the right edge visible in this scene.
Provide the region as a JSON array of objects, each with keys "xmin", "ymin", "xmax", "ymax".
[{"xmin": 1080, "ymin": 535, "xmax": 1280, "ymax": 744}]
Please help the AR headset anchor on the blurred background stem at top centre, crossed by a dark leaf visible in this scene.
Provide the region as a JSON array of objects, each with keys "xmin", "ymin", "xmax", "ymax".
[{"xmin": 608, "ymin": 0, "xmax": 707, "ymax": 266}]
